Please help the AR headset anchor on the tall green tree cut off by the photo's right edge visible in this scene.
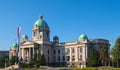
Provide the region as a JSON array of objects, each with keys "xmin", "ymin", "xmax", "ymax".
[{"xmin": 111, "ymin": 37, "xmax": 120, "ymax": 67}]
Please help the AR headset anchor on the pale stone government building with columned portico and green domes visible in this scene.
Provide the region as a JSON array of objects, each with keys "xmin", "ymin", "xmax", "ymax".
[{"xmin": 9, "ymin": 16, "xmax": 110, "ymax": 68}]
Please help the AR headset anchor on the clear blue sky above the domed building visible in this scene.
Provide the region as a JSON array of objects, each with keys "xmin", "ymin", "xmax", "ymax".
[{"xmin": 0, "ymin": 0, "xmax": 120, "ymax": 50}]
